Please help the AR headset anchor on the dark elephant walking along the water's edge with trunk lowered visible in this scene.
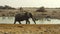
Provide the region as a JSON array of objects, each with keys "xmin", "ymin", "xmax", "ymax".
[{"xmin": 14, "ymin": 12, "xmax": 36, "ymax": 24}]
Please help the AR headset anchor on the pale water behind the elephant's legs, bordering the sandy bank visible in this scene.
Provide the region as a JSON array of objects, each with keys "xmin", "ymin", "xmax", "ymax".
[{"xmin": 0, "ymin": 17, "xmax": 60, "ymax": 24}]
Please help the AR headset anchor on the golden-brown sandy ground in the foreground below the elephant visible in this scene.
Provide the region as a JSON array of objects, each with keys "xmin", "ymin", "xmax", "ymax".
[{"xmin": 0, "ymin": 24, "xmax": 60, "ymax": 34}]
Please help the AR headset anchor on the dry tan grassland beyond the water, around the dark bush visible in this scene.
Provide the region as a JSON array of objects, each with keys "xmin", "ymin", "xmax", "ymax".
[{"xmin": 0, "ymin": 8, "xmax": 60, "ymax": 19}]
